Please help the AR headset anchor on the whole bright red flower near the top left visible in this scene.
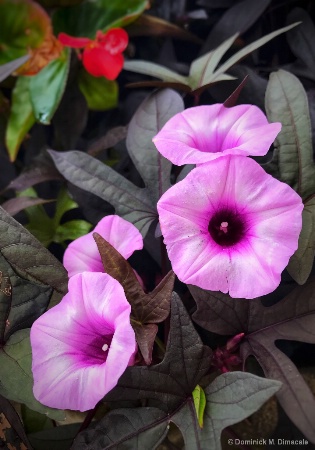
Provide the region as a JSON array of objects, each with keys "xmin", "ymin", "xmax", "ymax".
[{"xmin": 58, "ymin": 28, "xmax": 128, "ymax": 80}]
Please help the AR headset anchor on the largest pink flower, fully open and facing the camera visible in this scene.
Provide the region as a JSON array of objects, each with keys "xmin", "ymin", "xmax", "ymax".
[{"xmin": 158, "ymin": 155, "xmax": 303, "ymax": 298}]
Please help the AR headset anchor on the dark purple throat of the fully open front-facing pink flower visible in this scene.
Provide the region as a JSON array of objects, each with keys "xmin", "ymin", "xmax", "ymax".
[{"xmin": 208, "ymin": 209, "xmax": 245, "ymax": 247}]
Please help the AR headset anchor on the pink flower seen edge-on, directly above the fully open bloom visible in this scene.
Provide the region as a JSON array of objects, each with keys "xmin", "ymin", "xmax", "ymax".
[{"xmin": 153, "ymin": 104, "xmax": 281, "ymax": 166}]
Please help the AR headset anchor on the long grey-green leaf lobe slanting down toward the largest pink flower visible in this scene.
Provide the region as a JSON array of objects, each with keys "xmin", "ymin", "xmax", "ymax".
[{"xmin": 49, "ymin": 150, "xmax": 157, "ymax": 236}]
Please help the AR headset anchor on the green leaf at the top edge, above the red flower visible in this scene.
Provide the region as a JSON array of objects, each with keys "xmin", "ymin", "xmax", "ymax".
[{"xmin": 53, "ymin": 0, "xmax": 148, "ymax": 39}]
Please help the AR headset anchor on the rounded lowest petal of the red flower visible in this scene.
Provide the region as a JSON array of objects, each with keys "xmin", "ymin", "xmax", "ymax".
[{"xmin": 82, "ymin": 47, "xmax": 124, "ymax": 80}]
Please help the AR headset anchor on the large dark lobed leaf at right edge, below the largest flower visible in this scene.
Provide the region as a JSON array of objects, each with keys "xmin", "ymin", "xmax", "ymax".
[{"xmin": 190, "ymin": 281, "xmax": 315, "ymax": 442}]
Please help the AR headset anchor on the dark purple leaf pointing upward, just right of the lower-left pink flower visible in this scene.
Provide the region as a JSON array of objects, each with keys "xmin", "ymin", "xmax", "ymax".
[{"xmin": 105, "ymin": 294, "xmax": 212, "ymax": 411}]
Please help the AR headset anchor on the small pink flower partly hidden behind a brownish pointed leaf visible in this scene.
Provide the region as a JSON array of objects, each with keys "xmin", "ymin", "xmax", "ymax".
[{"xmin": 63, "ymin": 215, "xmax": 143, "ymax": 277}]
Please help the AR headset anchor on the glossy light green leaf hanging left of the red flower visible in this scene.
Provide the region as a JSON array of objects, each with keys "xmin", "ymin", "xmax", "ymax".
[{"xmin": 29, "ymin": 49, "xmax": 70, "ymax": 125}]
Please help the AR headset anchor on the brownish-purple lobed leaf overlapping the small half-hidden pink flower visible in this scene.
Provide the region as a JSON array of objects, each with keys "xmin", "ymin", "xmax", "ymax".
[{"xmin": 93, "ymin": 233, "xmax": 175, "ymax": 364}]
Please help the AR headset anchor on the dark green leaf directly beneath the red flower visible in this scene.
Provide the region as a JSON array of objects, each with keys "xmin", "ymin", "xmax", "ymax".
[{"xmin": 78, "ymin": 69, "xmax": 119, "ymax": 111}]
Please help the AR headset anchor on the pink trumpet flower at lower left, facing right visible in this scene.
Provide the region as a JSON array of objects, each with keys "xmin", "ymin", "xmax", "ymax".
[{"xmin": 31, "ymin": 272, "xmax": 137, "ymax": 411}]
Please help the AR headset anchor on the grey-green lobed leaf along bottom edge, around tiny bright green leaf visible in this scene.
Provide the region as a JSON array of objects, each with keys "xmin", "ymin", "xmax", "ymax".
[{"xmin": 72, "ymin": 372, "xmax": 280, "ymax": 450}]
